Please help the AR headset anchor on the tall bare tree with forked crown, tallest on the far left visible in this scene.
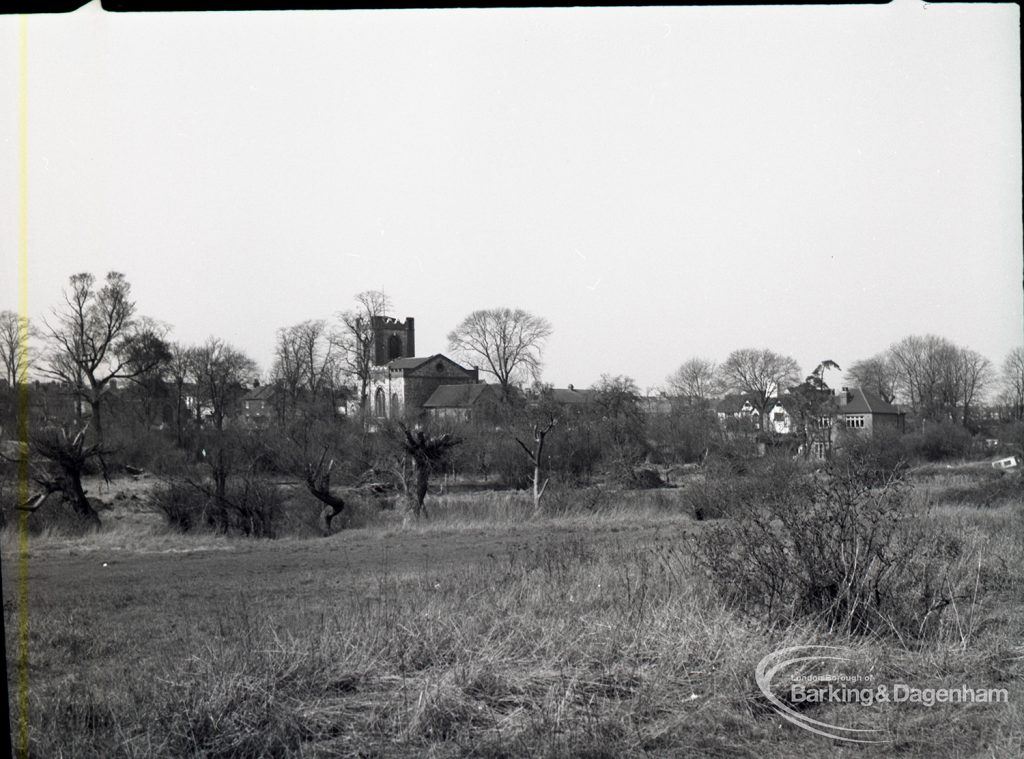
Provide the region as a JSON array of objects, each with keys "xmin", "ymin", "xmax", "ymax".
[{"xmin": 44, "ymin": 271, "xmax": 169, "ymax": 441}]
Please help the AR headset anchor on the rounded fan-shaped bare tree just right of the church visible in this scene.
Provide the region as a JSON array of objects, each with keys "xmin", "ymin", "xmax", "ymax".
[{"xmin": 447, "ymin": 308, "xmax": 552, "ymax": 397}]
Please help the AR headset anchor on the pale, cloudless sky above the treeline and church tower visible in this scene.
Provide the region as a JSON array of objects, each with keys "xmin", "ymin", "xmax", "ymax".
[{"xmin": 0, "ymin": 0, "xmax": 1024, "ymax": 397}]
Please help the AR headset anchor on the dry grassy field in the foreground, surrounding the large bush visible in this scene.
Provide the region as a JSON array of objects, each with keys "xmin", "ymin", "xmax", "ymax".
[{"xmin": 0, "ymin": 473, "xmax": 1024, "ymax": 758}]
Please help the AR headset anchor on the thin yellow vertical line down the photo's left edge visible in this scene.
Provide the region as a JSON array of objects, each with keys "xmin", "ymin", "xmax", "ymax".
[{"xmin": 16, "ymin": 14, "xmax": 29, "ymax": 759}]
